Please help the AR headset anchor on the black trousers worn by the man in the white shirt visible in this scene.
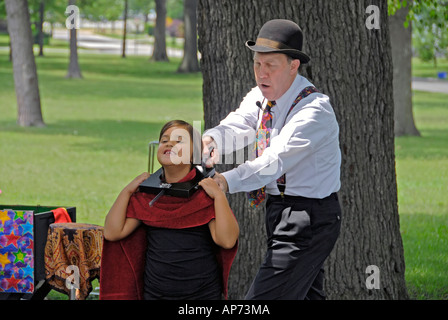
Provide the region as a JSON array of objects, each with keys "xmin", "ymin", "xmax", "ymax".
[{"xmin": 246, "ymin": 193, "xmax": 341, "ymax": 300}]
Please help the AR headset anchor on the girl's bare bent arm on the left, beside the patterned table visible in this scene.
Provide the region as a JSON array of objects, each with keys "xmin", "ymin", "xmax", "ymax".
[{"xmin": 104, "ymin": 172, "xmax": 149, "ymax": 241}]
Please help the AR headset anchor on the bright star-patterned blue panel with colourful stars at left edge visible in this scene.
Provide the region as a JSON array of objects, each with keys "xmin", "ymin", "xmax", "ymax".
[{"xmin": 0, "ymin": 210, "xmax": 34, "ymax": 293}]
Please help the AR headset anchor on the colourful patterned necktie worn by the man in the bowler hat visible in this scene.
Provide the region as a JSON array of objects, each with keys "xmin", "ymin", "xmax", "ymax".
[{"xmin": 247, "ymin": 101, "xmax": 275, "ymax": 208}]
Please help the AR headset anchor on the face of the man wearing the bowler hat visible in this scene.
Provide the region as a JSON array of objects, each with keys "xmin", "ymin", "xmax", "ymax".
[{"xmin": 254, "ymin": 52, "xmax": 300, "ymax": 101}]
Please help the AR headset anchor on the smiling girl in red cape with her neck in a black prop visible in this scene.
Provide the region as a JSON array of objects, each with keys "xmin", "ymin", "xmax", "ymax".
[{"xmin": 100, "ymin": 120, "xmax": 239, "ymax": 300}]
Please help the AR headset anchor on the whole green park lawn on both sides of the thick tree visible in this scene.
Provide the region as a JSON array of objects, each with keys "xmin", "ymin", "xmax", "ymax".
[{"xmin": 0, "ymin": 51, "xmax": 448, "ymax": 299}]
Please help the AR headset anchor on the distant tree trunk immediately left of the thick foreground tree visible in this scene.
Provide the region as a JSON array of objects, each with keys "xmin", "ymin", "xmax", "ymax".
[{"xmin": 177, "ymin": 0, "xmax": 200, "ymax": 72}]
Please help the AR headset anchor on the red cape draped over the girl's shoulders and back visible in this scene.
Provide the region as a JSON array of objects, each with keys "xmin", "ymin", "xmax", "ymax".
[{"xmin": 100, "ymin": 169, "xmax": 238, "ymax": 300}]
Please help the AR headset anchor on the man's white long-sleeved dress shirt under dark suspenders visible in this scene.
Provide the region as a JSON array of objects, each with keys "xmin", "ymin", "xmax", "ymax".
[{"xmin": 204, "ymin": 75, "xmax": 341, "ymax": 199}]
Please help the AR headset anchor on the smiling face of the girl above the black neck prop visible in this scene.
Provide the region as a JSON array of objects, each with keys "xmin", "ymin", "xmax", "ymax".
[{"xmin": 157, "ymin": 126, "xmax": 193, "ymax": 166}]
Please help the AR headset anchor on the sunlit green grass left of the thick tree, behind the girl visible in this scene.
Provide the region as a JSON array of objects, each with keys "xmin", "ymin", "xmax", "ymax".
[{"xmin": 0, "ymin": 54, "xmax": 202, "ymax": 228}]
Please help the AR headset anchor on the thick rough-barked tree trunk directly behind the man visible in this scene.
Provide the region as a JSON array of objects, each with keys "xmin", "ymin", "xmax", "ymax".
[{"xmin": 198, "ymin": 0, "xmax": 407, "ymax": 299}]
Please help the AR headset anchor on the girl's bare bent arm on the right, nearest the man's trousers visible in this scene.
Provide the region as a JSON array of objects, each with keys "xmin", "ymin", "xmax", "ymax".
[{"xmin": 199, "ymin": 178, "xmax": 240, "ymax": 249}]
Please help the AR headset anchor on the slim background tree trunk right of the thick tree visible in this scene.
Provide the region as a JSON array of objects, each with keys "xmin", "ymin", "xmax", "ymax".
[{"xmin": 389, "ymin": 5, "xmax": 420, "ymax": 136}]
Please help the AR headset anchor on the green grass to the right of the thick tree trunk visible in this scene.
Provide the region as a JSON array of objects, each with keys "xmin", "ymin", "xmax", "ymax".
[{"xmin": 396, "ymin": 92, "xmax": 448, "ymax": 299}]
